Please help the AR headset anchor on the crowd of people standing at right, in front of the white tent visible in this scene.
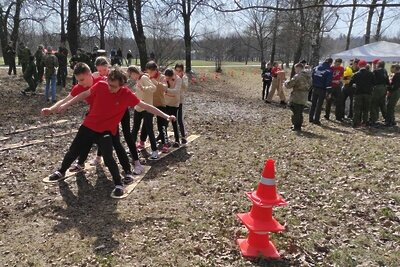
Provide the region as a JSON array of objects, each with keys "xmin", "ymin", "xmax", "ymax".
[{"xmin": 262, "ymin": 58, "xmax": 400, "ymax": 131}]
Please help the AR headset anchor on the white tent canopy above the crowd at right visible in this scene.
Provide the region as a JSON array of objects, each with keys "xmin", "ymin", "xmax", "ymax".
[{"xmin": 332, "ymin": 41, "xmax": 400, "ymax": 62}]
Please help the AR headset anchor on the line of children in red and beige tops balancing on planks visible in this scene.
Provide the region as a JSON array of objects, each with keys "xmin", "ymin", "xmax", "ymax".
[{"xmin": 42, "ymin": 57, "xmax": 188, "ymax": 196}]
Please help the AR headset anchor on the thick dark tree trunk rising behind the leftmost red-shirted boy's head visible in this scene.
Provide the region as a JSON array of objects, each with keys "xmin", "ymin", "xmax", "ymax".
[{"xmin": 67, "ymin": 0, "xmax": 79, "ymax": 55}]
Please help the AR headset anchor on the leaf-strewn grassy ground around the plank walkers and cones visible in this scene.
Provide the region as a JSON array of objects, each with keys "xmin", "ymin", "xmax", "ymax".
[{"xmin": 0, "ymin": 68, "xmax": 400, "ymax": 267}]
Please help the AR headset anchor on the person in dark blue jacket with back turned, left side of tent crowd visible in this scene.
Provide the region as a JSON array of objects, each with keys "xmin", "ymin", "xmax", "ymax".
[{"xmin": 309, "ymin": 58, "xmax": 333, "ymax": 125}]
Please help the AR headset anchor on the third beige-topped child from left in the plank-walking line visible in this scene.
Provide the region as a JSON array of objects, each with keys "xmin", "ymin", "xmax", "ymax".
[{"xmin": 164, "ymin": 69, "xmax": 182, "ymax": 147}]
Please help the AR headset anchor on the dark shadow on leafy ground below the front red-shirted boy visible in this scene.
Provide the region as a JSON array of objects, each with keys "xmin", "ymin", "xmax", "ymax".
[{"xmin": 49, "ymin": 167, "xmax": 133, "ymax": 256}]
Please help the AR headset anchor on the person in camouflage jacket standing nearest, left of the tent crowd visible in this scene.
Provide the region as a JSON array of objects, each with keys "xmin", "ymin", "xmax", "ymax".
[{"xmin": 285, "ymin": 63, "xmax": 311, "ymax": 131}]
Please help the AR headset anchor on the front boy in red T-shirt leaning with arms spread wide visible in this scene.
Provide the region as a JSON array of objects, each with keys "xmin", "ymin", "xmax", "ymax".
[{"xmin": 41, "ymin": 68, "xmax": 176, "ymax": 196}]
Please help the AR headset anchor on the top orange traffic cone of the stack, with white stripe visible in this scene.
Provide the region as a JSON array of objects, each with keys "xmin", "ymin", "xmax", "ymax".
[{"xmin": 246, "ymin": 159, "xmax": 287, "ymax": 207}]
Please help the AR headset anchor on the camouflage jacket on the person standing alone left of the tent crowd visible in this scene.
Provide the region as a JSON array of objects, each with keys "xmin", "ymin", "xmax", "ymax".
[{"xmin": 285, "ymin": 71, "xmax": 311, "ymax": 105}]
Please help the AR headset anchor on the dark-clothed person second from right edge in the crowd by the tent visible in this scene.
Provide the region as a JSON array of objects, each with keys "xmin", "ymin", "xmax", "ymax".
[{"xmin": 369, "ymin": 61, "xmax": 390, "ymax": 126}]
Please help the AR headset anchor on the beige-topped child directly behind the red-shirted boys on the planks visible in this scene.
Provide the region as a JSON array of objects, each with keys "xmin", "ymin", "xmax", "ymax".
[{"xmin": 128, "ymin": 65, "xmax": 159, "ymax": 160}]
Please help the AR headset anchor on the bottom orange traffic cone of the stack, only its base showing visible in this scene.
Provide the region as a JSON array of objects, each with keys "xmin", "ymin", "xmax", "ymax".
[{"xmin": 237, "ymin": 231, "xmax": 280, "ymax": 259}]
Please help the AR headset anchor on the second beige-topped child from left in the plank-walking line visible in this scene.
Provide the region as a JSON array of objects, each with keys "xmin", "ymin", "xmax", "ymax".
[{"xmin": 139, "ymin": 61, "xmax": 169, "ymax": 153}]
